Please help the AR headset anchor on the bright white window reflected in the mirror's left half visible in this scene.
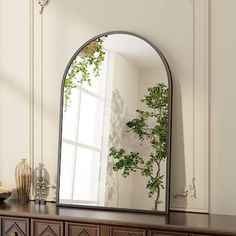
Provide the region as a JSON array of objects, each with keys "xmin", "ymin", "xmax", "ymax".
[{"xmin": 60, "ymin": 53, "xmax": 111, "ymax": 205}]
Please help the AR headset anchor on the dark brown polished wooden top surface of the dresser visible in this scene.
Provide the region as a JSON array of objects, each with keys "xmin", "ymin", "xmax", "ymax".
[{"xmin": 0, "ymin": 200, "xmax": 236, "ymax": 235}]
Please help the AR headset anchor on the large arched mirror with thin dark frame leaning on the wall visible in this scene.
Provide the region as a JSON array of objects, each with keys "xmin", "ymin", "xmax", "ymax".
[{"xmin": 57, "ymin": 32, "xmax": 172, "ymax": 213}]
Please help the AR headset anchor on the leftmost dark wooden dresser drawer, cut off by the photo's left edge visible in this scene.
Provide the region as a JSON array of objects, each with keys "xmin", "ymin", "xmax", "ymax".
[{"xmin": 0, "ymin": 217, "xmax": 29, "ymax": 236}]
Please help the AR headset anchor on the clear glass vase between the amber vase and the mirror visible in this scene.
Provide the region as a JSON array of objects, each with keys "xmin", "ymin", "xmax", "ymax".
[{"xmin": 34, "ymin": 163, "xmax": 48, "ymax": 204}]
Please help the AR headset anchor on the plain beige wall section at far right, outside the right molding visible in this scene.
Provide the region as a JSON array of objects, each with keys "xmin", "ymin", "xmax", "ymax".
[{"xmin": 210, "ymin": 0, "xmax": 236, "ymax": 214}]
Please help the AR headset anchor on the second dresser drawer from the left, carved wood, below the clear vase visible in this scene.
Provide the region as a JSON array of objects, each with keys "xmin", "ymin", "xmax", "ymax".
[{"xmin": 31, "ymin": 219, "xmax": 63, "ymax": 236}]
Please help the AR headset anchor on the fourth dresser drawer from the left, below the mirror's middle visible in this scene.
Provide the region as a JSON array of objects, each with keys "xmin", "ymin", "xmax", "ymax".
[{"xmin": 110, "ymin": 227, "xmax": 146, "ymax": 236}]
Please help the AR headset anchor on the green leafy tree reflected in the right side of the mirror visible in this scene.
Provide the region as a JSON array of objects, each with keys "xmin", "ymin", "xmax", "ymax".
[{"xmin": 109, "ymin": 83, "xmax": 168, "ymax": 210}]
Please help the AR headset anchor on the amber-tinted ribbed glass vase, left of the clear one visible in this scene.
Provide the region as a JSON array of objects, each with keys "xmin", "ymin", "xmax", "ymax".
[{"xmin": 15, "ymin": 159, "xmax": 31, "ymax": 204}]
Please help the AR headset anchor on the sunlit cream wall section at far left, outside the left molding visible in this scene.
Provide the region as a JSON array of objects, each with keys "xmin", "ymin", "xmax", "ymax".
[{"xmin": 0, "ymin": 0, "xmax": 31, "ymax": 187}]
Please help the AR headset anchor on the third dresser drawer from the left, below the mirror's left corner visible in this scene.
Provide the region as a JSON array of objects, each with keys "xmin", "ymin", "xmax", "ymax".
[{"xmin": 65, "ymin": 222, "xmax": 100, "ymax": 236}]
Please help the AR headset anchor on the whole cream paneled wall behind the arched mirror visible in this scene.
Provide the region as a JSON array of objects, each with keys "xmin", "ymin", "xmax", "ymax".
[{"xmin": 0, "ymin": 0, "xmax": 236, "ymax": 214}]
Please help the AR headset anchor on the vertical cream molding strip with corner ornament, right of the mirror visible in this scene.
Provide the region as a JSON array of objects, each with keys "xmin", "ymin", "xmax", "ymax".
[{"xmin": 171, "ymin": 0, "xmax": 209, "ymax": 212}]
